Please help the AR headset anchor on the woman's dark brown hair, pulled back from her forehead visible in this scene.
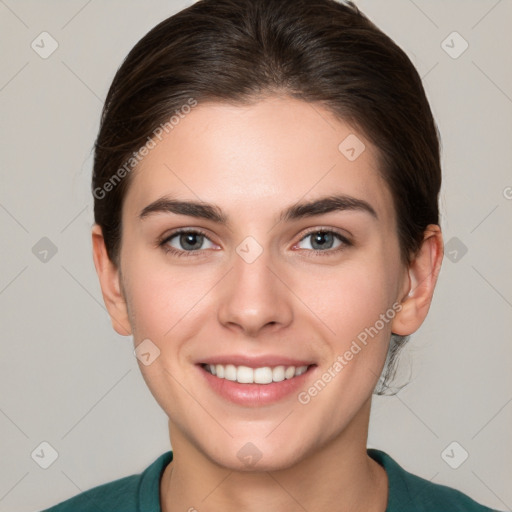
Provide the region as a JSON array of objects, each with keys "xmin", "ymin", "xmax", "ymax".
[{"xmin": 92, "ymin": 0, "xmax": 441, "ymax": 394}]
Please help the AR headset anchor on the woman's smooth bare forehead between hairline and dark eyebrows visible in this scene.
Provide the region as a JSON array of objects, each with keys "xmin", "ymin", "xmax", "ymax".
[{"xmin": 125, "ymin": 97, "xmax": 394, "ymax": 226}]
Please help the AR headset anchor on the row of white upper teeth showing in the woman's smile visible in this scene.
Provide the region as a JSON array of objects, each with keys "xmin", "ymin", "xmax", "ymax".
[{"xmin": 204, "ymin": 364, "xmax": 308, "ymax": 384}]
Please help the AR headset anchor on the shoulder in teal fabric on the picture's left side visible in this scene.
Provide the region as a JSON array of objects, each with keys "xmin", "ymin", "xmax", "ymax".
[{"xmin": 42, "ymin": 451, "xmax": 172, "ymax": 512}]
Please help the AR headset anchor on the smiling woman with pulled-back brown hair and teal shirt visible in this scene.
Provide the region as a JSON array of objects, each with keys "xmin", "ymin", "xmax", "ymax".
[{"xmin": 43, "ymin": 0, "xmax": 500, "ymax": 512}]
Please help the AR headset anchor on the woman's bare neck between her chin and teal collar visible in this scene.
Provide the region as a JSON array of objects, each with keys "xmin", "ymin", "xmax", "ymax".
[{"xmin": 160, "ymin": 401, "xmax": 388, "ymax": 512}]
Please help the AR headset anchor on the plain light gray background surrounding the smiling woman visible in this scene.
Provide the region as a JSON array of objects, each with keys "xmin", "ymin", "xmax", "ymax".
[{"xmin": 0, "ymin": 0, "xmax": 512, "ymax": 512}]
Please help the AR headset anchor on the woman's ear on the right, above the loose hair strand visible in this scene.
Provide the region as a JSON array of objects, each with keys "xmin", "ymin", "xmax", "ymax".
[{"xmin": 391, "ymin": 224, "xmax": 443, "ymax": 336}]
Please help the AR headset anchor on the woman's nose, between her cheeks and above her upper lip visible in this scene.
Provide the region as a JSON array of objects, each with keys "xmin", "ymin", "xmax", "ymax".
[{"xmin": 218, "ymin": 242, "xmax": 293, "ymax": 337}]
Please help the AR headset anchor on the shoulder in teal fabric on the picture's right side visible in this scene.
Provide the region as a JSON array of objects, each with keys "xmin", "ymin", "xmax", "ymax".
[{"xmin": 367, "ymin": 448, "xmax": 496, "ymax": 512}]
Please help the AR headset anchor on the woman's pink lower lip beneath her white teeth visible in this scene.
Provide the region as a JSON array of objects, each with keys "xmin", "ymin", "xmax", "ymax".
[{"xmin": 197, "ymin": 365, "xmax": 316, "ymax": 407}]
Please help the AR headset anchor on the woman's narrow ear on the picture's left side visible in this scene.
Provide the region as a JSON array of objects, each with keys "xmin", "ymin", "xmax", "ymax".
[{"xmin": 92, "ymin": 224, "xmax": 132, "ymax": 336}]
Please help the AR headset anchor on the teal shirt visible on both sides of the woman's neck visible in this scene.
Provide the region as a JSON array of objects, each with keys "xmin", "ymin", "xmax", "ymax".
[{"xmin": 43, "ymin": 448, "xmax": 496, "ymax": 512}]
